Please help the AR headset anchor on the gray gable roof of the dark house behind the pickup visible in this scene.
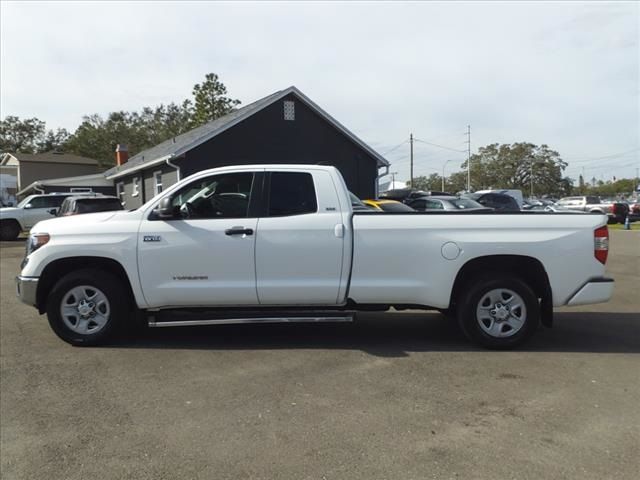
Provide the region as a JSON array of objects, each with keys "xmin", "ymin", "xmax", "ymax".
[{"xmin": 105, "ymin": 86, "xmax": 389, "ymax": 178}]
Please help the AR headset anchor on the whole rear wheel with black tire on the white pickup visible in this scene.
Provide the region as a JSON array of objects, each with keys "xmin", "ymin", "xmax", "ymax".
[{"xmin": 457, "ymin": 272, "xmax": 540, "ymax": 350}]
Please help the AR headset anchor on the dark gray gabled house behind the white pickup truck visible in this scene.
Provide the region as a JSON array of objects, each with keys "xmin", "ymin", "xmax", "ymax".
[{"xmin": 105, "ymin": 87, "xmax": 389, "ymax": 208}]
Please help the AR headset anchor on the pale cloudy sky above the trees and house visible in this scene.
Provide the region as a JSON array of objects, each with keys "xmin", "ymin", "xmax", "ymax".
[{"xmin": 0, "ymin": 1, "xmax": 640, "ymax": 180}]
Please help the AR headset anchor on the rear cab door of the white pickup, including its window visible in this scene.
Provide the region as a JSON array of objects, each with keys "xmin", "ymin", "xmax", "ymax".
[{"xmin": 256, "ymin": 170, "xmax": 348, "ymax": 305}]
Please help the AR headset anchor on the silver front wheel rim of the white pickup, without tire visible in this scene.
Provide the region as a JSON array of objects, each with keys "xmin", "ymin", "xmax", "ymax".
[{"xmin": 60, "ymin": 285, "xmax": 111, "ymax": 335}]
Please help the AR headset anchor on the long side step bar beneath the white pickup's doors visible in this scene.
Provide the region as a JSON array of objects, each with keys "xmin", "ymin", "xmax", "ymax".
[{"xmin": 148, "ymin": 310, "xmax": 355, "ymax": 327}]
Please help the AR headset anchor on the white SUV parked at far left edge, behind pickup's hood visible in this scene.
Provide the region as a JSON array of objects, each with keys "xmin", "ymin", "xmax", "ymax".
[{"xmin": 0, "ymin": 192, "xmax": 74, "ymax": 240}]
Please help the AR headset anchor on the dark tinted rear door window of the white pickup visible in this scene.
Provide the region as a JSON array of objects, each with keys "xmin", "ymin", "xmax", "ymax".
[{"xmin": 268, "ymin": 172, "xmax": 318, "ymax": 217}]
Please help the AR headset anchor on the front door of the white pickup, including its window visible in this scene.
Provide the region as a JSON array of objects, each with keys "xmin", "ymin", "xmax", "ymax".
[{"xmin": 138, "ymin": 171, "xmax": 264, "ymax": 308}]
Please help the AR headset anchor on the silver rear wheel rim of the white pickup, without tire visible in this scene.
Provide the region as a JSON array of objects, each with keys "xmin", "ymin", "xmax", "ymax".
[{"xmin": 476, "ymin": 288, "xmax": 527, "ymax": 338}]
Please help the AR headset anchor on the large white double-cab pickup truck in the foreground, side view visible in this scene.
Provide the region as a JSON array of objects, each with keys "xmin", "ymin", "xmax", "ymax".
[{"xmin": 16, "ymin": 165, "xmax": 613, "ymax": 348}]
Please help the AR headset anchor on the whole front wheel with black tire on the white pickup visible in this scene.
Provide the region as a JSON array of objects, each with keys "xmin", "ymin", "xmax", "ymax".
[{"xmin": 47, "ymin": 269, "xmax": 130, "ymax": 346}]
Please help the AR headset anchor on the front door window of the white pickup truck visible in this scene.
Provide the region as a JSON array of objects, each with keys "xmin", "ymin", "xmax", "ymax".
[{"xmin": 172, "ymin": 172, "xmax": 253, "ymax": 219}]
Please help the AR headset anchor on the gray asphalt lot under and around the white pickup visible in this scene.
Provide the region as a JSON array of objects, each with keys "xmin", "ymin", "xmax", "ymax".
[{"xmin": 0, "ymin": 230, "xmax": 640, "ymax": 479}]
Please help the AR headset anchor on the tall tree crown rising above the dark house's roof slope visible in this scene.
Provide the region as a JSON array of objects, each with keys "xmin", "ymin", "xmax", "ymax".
[{"xmin": 192, "ymin": 73, "xmax": 240, "ymax": 127}]
